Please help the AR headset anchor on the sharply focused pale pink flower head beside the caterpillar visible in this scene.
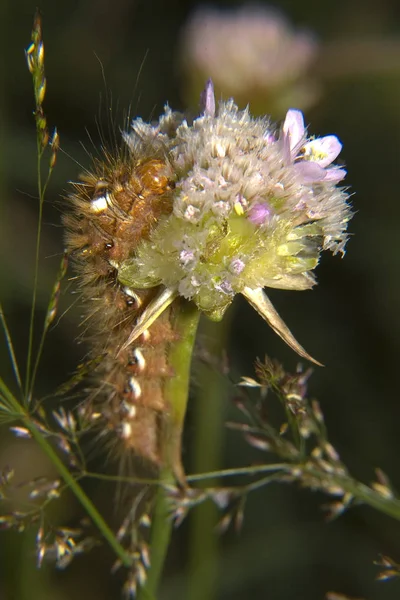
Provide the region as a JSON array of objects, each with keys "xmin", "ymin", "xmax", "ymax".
[{"xmin": 118, "ymin": 81, "xmax": 350, "ymax": 356}]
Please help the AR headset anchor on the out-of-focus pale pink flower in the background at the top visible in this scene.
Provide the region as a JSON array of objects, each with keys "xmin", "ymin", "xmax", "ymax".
[{"xmin": 181, "ymin": 5, "xmax": 317, "ymax": 116}]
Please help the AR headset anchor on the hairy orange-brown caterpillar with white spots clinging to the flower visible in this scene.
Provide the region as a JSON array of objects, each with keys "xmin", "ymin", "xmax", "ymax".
[{"xmin": 63, "ymin": 145, "xmax": 175, "ymax": 464}]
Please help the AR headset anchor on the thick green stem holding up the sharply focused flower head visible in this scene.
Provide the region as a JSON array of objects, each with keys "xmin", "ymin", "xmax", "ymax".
[{"xmin": 137, "ymin": 299, "xmax": 200, "ymax": 600}]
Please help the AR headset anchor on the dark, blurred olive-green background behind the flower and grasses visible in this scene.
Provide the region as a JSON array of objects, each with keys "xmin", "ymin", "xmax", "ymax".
[{"xmin": 0, "ymin": 0, "xmax": 400, "ymax": 600}]
